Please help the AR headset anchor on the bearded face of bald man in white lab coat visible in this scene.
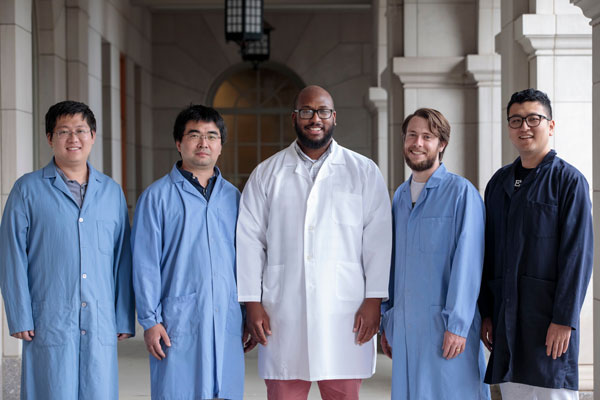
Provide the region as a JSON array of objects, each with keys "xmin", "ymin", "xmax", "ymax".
[{"xmin": 292, "ymin": 88, "xmax": 335, "ymax": 149}]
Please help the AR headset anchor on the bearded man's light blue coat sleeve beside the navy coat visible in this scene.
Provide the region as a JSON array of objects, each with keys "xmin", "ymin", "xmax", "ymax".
[{"xmin": 442, "ymin": 186, "xmax": 485, "ymax": 337}]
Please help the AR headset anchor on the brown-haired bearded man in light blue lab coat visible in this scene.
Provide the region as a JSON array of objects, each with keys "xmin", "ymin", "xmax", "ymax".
[{"xmin": 381, "ymin": 108, "xmax": 489, "ymax": 400}]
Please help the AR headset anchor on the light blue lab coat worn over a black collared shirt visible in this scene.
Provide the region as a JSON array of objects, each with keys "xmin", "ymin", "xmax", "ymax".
[{"xmin": 132, "ymin": 166, "xmax": 244, "ymax": 400}]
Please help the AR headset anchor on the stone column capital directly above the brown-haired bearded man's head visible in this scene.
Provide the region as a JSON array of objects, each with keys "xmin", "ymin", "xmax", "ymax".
[{"xmin": 393, "ymin": 57, "xmax": 465, "ymax": 88}]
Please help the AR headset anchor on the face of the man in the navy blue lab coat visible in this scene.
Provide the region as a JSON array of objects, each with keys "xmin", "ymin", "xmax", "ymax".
[{"xmin": 508, "ymin": 101, "xmax": 554, "ymax": 157}]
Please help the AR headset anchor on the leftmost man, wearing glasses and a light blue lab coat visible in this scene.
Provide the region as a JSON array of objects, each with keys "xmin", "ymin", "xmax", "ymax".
[{"xmin": 0, "ymin": 101, "xmax": 135, "ymax": 400}]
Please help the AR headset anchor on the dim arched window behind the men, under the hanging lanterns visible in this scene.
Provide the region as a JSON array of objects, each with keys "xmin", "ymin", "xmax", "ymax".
[{"xmin": 212, "ymin": 65, "xmax": 304, "ymax": 190}]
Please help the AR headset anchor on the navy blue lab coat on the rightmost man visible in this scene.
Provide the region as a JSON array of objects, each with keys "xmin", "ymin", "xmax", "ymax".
[{"xmin": 479, "ymin": 150, "xmax": 593, "ymax": 390}]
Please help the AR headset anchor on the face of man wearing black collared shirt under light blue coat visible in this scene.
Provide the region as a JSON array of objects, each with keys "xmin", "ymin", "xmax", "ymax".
[{"xmin": 176, "ymin": 121, "xmax": 222, "ymax": 172}]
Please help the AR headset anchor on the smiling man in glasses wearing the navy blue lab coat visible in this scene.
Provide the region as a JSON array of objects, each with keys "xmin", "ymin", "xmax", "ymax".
[{"xmin": 479, "ymin": 89, "xmax": 593, "ymax": 400}]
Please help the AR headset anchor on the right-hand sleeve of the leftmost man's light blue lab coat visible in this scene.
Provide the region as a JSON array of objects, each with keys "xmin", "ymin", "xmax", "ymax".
[{"xmin": 114, "ymin": 192, "xmax": 135, "ymax": 335}]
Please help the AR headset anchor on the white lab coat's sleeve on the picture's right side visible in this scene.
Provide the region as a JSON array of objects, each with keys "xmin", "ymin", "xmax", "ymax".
[{"xmin": 362, "ymin": 163, "xmax": 392, "ymax": 299}]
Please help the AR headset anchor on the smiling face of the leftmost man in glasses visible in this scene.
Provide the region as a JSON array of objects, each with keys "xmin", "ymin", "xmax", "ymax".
[{"xmin": 46, "ymin": 113, "xmax": 96, "ymax": 168}]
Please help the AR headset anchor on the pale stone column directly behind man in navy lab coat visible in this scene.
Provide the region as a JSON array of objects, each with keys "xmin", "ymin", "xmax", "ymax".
[{"xmin": 496, "ymin": 0, "xmax": 598, "ymax": 391}]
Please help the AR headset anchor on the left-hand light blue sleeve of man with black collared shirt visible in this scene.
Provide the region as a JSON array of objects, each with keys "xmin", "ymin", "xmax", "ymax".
[{"xmin": 131, "ymin": 192, "xmax": 162, "ymax": 330}]
